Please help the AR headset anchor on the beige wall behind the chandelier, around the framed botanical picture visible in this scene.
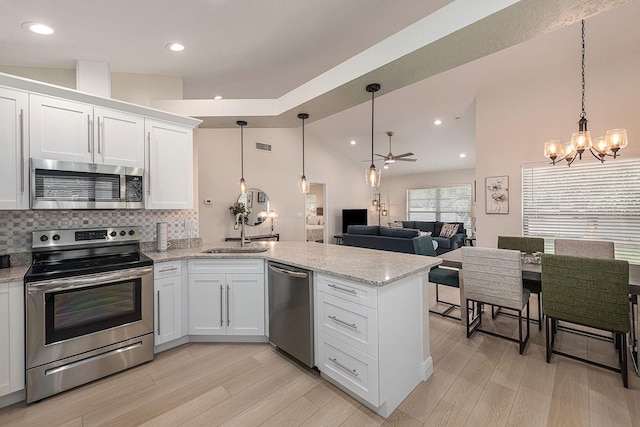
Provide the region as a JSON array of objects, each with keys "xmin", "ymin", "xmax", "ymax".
[{"xmin": 476, "ymin": 53, "xmax": 640, "ymax": 247}]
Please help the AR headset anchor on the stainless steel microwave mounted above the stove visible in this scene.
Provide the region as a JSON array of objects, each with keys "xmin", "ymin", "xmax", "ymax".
[{"xmin": 31, "ymin": 159, "xmax": 144, "ymax": 209}]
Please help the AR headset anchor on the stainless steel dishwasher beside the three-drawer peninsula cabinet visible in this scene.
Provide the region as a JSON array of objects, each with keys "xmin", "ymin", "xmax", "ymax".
[{"xmin": 269, "ymin": 262, "xmax": 314, "ymax": 368}]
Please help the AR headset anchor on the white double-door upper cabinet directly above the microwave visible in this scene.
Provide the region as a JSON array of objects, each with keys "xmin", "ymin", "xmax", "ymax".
[{"xmin": 29, "ymin": 94, "xmax": 144, "ymax": 167}]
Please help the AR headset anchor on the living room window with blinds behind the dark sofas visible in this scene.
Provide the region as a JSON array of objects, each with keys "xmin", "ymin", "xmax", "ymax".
[{"xmin": 407, "ymin": 185, "xmax": 471, "ymax": 230}]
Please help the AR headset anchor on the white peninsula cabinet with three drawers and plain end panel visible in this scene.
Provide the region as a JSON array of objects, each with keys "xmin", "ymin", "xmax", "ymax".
[{"xmin": 314, "ymin": 274, "xmax": 424, "ymax": 417}]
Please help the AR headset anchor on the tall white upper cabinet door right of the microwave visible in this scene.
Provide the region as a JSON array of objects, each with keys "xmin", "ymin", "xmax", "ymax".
[{"xmin": 145, "ymin": 120, "xmax": 193, "ymax": 209}]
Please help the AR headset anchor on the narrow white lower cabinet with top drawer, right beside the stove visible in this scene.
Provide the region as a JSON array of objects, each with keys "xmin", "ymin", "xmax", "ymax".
[{"xmin": 153, "ymin": 260, "xmax": 182, "ymax": 345}]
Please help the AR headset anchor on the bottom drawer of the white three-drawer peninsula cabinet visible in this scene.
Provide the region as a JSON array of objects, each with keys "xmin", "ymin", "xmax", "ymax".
[{"xmin": 316, "ymin": 335, "xmax": 380, "ymax": 407}]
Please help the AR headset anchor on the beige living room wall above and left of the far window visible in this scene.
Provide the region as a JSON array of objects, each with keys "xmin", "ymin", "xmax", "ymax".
[{"xmin": 380, "ymin": 168, "xmax": 475, "ymax": 225}]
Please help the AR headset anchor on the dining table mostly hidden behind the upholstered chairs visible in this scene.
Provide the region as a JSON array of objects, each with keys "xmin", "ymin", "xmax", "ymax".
[{"xmin": 438, "ymin": 248, "xmax": 640, "ymax": 376}]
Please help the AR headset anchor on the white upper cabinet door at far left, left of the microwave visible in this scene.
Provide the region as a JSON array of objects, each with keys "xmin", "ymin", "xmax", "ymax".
[{"xmin": 0, "ymin": 88, "xmax": 29, "ymax": 209}]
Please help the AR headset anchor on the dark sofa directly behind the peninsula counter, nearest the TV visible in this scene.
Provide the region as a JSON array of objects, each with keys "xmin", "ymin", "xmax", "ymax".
[{"xmin": 342, "ymin": 225, "xmax": 435, "ymax": 256}]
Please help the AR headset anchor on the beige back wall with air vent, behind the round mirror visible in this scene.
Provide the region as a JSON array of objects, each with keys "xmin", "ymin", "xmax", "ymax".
[{"xmin": 194, "ymin": 127, "xmax": 368, "ymax": 242}]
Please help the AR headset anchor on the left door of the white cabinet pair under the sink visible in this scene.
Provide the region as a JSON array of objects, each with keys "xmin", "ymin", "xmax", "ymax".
[{"xmin": 189, "ymin": 274, "xmax": 227, "ymax": 335}]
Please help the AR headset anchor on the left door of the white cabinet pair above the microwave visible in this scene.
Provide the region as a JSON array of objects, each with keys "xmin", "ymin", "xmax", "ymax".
[{"xmin": 29, "ymin": 95, "xmax": 93, "ymax": 163}]
